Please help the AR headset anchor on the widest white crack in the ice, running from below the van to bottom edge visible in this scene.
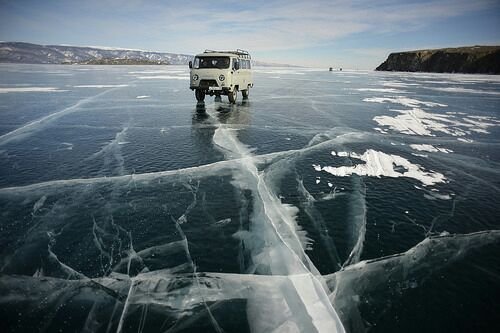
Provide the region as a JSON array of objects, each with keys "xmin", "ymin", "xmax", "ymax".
[{"xmin": 213, "ymin": 114, "xmax": 344, "ymax": 332}]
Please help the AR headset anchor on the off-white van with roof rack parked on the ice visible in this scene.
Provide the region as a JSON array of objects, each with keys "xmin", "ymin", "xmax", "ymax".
[{"xmin": 189, "ymin": 49, "xmax": 253, "ymax": 104}]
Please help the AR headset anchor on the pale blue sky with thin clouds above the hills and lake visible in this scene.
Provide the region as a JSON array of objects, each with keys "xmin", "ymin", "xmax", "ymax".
[{"xmin": 0, "ymin": 0, "xmax": 500, "ymax": 69}]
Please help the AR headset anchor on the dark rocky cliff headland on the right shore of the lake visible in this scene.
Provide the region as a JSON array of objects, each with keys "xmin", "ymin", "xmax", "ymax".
[{"xmin": 376, "ymin": 46, "xmax": 500, "ymax": 74}]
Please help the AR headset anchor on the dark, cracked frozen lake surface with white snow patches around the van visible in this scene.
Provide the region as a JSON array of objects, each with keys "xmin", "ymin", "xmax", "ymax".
[{"xmin": 0, "ymin": 64, "xmax": 500, "ymax": 333}]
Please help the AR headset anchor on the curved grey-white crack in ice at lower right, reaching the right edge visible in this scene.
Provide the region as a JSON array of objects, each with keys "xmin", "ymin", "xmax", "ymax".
[{"xmin": 326, "ymin": 230, "xmax": 500, "ymax": 331}]
